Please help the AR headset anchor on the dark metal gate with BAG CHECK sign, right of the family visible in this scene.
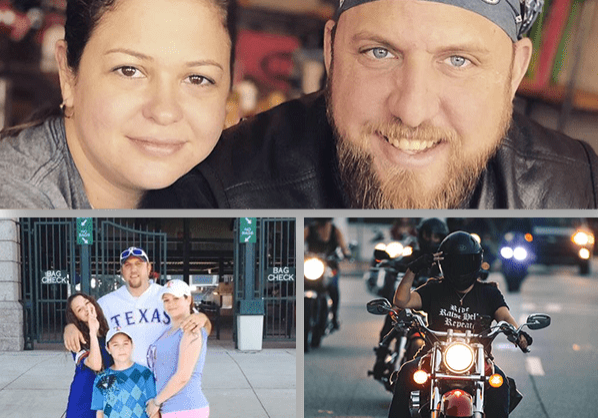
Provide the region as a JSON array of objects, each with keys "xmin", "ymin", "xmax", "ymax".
[{"xmin": 234, "ymin": 218, "xmax": 297, "ymax": 341}]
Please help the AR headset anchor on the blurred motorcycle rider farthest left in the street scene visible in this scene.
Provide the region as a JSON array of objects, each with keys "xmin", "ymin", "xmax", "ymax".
[{"xmin": 303, "ymin": 217, "xmax": 351, "ymax": 330}]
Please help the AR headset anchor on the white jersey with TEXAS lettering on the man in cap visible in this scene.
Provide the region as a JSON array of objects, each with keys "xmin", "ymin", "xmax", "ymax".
[{"xmin": 98, "ymin": 283, "xmax": 170, "ymax": 367}]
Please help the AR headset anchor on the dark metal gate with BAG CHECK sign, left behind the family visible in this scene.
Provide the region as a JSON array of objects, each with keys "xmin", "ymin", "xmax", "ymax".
[{"xmin": 21, "ymin": 218, "xmax": 167, "ymax": 349}]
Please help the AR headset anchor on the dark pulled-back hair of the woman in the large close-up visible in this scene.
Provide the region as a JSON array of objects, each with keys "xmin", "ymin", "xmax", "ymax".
[{"xmin": 0, "ymin": 0, "xmax": 237, "ymax": 139}]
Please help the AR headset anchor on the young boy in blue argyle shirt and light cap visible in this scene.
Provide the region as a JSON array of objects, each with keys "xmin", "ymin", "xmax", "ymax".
[{"xmin": 91, "ymin": 328, "xmax": 156, "ymax": 418}]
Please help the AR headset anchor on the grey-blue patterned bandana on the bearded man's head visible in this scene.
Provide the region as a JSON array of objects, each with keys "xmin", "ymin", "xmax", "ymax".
[{"xmin": 334, "ymin": 0, "xmax": 544, "ymax": 42}]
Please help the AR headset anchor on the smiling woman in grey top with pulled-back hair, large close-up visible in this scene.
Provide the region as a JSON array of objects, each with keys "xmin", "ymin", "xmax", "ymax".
[{"xmin": 0, "ymin": 0, "xmax": 234, "ymax": 209}]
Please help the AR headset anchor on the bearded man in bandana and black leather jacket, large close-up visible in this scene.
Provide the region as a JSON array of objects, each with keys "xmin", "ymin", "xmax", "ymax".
[{"xmin": 146, "ymin": 0, "xmax": 598, "ymax": 209}]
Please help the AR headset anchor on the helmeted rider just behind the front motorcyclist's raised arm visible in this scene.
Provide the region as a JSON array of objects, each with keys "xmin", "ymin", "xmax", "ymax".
[{"xmin": 374, "ymin": 218, "xmax": 449, "ymax": 380}]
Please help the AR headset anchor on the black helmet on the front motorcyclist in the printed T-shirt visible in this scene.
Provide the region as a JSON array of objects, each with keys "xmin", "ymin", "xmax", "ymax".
[{"xmin": 438, "ymin": 231, "xmax": 484, "ymax": 291}]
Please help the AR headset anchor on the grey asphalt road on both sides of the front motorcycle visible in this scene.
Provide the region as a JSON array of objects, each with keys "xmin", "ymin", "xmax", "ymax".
[{"xmin": 304, "ymin": 261, "xmax": 598, "ymax": 418}]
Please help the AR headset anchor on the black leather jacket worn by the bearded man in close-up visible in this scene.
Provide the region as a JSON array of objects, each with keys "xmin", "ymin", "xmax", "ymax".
[{"xmin": 144, "ymin": 92, "xmax": 598, "ymax": 209}]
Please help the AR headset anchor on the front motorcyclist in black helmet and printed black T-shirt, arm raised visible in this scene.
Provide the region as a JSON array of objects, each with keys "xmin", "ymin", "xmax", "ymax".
[{"xmin": 389, "ymin": 231, "xmax": 532, "ymax": 418}]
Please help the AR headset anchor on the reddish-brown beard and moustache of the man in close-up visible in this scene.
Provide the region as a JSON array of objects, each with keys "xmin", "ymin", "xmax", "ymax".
[{"xmin": 326, "ymin": 72, "xmax": 513, "ymax": 209}]
